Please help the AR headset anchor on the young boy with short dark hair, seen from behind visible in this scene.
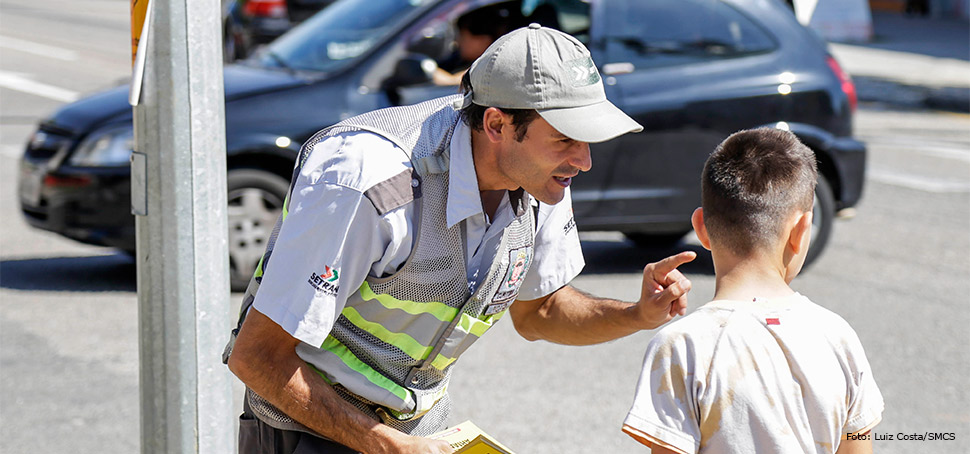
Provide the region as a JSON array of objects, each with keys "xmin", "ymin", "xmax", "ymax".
[{"xmin": 623, "ymin": 129, "xmax": 883, "ymax": 454}]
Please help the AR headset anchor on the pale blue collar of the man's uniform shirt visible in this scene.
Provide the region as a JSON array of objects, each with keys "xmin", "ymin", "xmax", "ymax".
[{"xmin": 447, "ymin": 120, "xmax": 531, "ymax": 228}]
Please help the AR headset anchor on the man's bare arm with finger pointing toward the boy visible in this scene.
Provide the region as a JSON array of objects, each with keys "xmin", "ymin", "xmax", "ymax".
[{"xmin": 509, "ymin": 252, "xmax": 697, "ymax": 345}]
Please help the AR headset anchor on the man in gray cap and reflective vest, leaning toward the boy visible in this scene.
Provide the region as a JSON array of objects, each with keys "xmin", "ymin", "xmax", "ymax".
[{"xmin": 227, "ymin": 24, "xmax": 693, "ymax": 453}]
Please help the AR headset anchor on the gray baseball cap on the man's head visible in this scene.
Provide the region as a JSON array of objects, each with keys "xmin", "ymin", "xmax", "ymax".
[{"xmin": 465, "ymin": 24, "xmax": 643, "ymax": 143}]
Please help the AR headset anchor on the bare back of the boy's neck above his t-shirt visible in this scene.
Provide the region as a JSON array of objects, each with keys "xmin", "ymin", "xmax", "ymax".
[{"xmin": 713, "ymin": 253, "xmax": 795, "ymax": 301}]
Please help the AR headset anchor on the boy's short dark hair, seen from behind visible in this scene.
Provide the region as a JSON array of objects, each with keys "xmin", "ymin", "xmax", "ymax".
[{"xmin": 701, "ymin": 128, "xmax": 818, "ymax": 256}]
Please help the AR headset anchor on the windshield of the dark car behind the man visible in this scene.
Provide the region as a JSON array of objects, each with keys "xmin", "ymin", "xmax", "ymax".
[{"xmin": 256, "ymin": 0, "xmax": 435, "ymax": 72}]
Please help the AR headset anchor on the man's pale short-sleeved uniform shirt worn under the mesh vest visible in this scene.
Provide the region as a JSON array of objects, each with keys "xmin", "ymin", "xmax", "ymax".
[{"xmin": 253, "ymin": 122, "xmax": 585, "ymax": 345}]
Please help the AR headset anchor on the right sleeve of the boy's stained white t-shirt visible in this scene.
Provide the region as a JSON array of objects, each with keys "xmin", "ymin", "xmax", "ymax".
[{"xmin": 843, "ymin": 331, "xmax": 885, "ymax": 433}]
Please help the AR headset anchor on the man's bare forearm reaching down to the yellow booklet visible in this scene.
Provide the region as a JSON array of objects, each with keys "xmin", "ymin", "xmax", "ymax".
[{"xmin": 229, "ymin": 309, "xmax": 452, "ymax": 454}]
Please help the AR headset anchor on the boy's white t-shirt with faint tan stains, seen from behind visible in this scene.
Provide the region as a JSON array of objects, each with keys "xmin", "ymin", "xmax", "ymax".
[{"xmin": 623, "ymin": 293, "xmax": 883, "ymax": 453}]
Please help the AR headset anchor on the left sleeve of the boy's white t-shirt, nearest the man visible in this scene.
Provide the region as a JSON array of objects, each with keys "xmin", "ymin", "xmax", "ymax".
[{"xmin": 623, "ymin": 328, "xmax": 701, "ymax": 454}]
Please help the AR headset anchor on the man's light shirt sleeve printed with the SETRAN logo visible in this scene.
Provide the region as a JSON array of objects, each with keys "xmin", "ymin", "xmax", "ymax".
[{"xmin": 253, "ymin": 136, "xmax": 395, "ymax": 346}]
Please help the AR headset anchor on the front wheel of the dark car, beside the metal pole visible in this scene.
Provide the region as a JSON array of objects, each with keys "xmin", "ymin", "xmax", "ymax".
[{"xmin": 226, "ymin": 169, "xmax": 290, "ymax": 292}]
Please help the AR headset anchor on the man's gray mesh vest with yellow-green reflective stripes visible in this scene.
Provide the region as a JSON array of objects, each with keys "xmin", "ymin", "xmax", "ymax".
[{"xmin": 234, "ymin": 96, "xmax": 535, "ymax": 436}]
